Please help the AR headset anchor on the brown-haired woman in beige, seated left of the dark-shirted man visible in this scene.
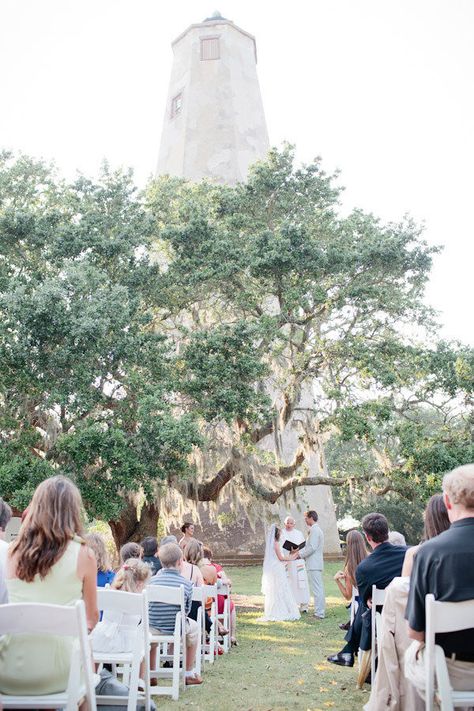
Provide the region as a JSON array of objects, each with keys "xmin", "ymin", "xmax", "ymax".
[{"xmin": 364, "ymin": 494, "xmax": 450, "ymax": 711}]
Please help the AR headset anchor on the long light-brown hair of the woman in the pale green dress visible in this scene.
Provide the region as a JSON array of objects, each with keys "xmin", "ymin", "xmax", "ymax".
[{"xmin": 10, "ymin": 475, "xmax": 83, "ymax": 583}]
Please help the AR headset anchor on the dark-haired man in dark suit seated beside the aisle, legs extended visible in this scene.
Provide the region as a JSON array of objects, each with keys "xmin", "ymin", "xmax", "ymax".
[{"xmin": 327, "ymin": 513, "xmax": 406, "ymax": 667}]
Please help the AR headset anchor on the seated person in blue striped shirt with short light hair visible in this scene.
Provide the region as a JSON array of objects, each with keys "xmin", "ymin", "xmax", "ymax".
[{"xmin": 150, "ymin": 543, "xmax": 202, "ymax": 685}]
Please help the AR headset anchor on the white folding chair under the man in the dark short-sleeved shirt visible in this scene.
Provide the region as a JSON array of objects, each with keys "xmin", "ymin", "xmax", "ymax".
[{"xmin": 425, "ymin": 594, "xmax": 474, "ymax": 711}]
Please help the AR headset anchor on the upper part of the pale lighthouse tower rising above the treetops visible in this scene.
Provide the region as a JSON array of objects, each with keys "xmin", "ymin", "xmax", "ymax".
[{"xmin": 157, "ymin": 12, "xmax": 269, "ymax": 185}]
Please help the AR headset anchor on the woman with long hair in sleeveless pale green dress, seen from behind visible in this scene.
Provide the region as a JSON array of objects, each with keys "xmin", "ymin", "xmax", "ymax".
[{"xmin": 0, "ymin": 476, "xmax": 99, "ymax": 696}]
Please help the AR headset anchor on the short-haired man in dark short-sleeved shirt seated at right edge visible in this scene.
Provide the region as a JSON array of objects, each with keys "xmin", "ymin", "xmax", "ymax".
[{"xmin": 405, "ymin": 464, "xmax": 474, "ymax": 693}]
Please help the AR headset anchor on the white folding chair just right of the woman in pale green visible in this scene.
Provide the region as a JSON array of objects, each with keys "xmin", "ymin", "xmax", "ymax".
[{"xmin": 93, "ymin": 588, "xmax": 151, "ymax": 711}]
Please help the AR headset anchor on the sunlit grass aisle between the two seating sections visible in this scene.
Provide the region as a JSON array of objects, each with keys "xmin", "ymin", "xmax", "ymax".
[{"xmin": 155, "ymin": 562, "xmax": 370, "ymax": 711}]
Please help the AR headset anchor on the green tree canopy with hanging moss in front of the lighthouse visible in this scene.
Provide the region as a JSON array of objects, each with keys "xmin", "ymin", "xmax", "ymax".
[{"xmin": 0, "ymin": 147, "xmax": 474, "ymax": 541}]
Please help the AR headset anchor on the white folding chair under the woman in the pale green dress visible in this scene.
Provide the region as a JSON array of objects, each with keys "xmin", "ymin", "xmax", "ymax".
[{"xmin": 0, "ymin": 600, "xmax": 97, "ymax": 711}]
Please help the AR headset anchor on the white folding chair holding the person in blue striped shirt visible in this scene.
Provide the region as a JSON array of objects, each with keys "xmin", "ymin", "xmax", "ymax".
[{"xmin": 146, "ymin": 585, "xmax": 186, "ymax": 701}]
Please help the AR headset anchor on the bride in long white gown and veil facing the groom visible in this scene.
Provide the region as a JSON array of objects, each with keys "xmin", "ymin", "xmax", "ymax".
[{"xmin": 261, "ymin": 523, "xmax": 300, "ymax": 622}]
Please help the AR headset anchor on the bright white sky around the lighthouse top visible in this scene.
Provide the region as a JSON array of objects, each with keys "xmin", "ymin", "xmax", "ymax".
[{"xmin": 0, "ymin": 0, "xmax": 474, "ymax": 344}]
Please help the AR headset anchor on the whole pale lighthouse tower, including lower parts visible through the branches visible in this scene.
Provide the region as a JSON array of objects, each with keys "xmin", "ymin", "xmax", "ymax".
[{"xmin": 157, "ymin": 13, "xmax": 340, "ymax": 560}]
